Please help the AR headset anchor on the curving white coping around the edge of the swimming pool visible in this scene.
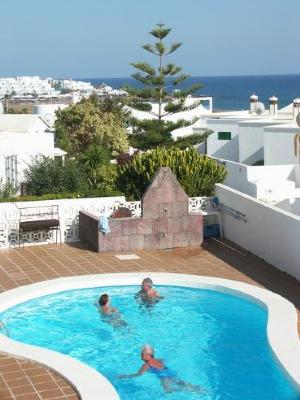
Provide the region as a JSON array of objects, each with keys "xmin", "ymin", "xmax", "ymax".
[{"xmin": 0, "ymin": 272, "xmax": 300, "ymax": 400}]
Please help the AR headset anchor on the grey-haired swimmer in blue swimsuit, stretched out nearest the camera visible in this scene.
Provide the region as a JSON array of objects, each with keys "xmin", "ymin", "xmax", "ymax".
[{"xmin": 119, "ymin": 344, "xmax": 205, "ymax": 393}]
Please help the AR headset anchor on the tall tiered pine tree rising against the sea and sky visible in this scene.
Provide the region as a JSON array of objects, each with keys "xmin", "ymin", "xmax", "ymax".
[{"xmin": 125, "ymin": 23, "xmax": 207, "ymax": 150}]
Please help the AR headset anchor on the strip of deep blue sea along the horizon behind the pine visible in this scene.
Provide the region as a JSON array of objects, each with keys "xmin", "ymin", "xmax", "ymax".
[{"xmin": 78, "ymin": 74, "xmax": 300, "ymax": 111}]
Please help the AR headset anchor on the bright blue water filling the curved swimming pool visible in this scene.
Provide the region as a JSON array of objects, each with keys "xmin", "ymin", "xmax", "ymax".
[{"xmin": 0, "ymin": 286, "xmax": 300, "ymax": 400}]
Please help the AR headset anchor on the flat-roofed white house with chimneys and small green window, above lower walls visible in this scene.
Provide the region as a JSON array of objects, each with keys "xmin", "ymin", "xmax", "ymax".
[{"xmin": 202, "ymin": 96, "xmax": 300, "ymax": 165}]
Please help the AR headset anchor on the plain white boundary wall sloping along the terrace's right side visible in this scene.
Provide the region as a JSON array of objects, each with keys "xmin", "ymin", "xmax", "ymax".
[{"xmin": 216, "ymin": 184, "xmax": 300, "ymax": 280}]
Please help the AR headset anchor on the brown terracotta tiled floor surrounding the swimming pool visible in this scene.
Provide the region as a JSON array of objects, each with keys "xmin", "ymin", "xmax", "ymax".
[{"xmin": 0, "ymin": 240, "xmax": 300, "ymax": 400}]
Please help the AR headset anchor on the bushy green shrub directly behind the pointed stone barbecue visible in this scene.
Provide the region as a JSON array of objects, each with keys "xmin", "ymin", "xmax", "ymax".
[{"xmin": 117, "ymin": 147, "xmax": 227, "ymax": 200}]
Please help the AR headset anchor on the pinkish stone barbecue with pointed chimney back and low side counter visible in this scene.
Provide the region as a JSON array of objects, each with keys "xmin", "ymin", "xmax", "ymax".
[{"xmin": 79, "ymin": 168, "xmax": 203, "ymax": 252}]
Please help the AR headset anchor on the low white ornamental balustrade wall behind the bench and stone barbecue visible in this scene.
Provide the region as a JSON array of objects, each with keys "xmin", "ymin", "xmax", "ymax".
[{"xmin": 0, "ymin": 196, "xmax": 213, "ymax": 249}]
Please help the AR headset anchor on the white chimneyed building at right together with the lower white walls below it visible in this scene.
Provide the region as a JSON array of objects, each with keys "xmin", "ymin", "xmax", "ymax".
[{"xmin": 197, "ymin": 95, "xmax": 300, "ymax": 209}]
